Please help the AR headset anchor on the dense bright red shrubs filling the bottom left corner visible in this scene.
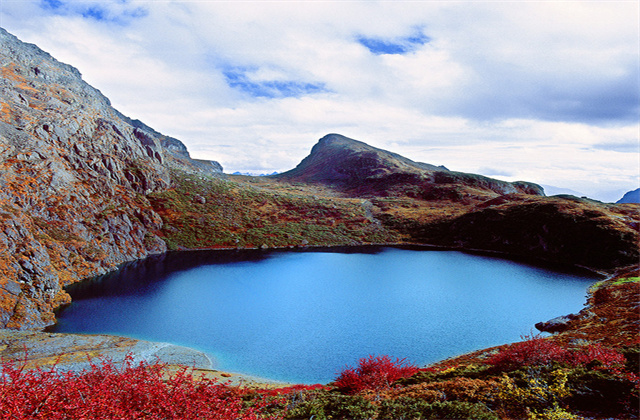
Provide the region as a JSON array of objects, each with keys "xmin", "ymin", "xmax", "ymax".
[{"xmin": 0, "ymin": 358, "xmax": 272, "ymax": 420}]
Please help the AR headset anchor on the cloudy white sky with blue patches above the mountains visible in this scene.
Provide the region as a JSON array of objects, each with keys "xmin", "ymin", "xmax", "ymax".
[{"xmin": 0, "ymin": 0, "xmax": 640, "ymax": 201}]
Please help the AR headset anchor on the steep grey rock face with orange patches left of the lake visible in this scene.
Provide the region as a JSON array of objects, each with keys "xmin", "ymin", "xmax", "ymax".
[{"xmin": 0, "ymin": 29, "xmax": 221, "ymax": 328}]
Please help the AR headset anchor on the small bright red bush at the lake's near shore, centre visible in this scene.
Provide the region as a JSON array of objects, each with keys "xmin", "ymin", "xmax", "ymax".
[{"xmin": 334, "ymin": 355, "xmax": 418, "ymax": 394}]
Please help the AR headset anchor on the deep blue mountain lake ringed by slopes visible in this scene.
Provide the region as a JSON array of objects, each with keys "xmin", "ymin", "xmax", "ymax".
[{"xmin": 53, "ymin": 247, "xmax": 595, "ymax": 383}]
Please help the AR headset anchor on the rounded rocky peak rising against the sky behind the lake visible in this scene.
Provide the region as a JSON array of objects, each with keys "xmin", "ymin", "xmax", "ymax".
[{"xmin": 274, "ymin": 134, "xmax": 544, "ymax": 201}]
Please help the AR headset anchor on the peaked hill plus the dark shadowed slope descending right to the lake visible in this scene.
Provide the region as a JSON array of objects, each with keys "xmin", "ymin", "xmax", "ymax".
[{"xmin": 272, "ymin": 134, "xmax": 640, "ymax": 271}]
